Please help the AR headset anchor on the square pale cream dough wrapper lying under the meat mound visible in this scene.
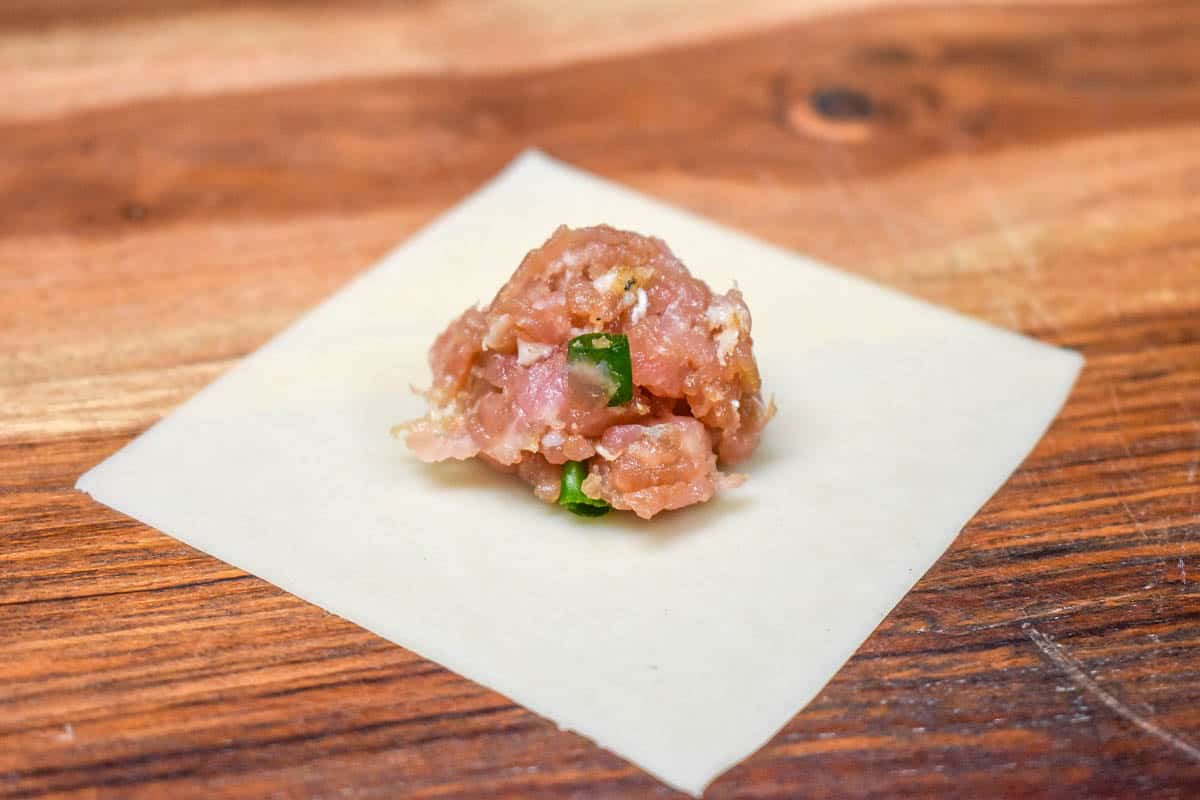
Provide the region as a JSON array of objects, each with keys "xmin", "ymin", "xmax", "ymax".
[{"xmin": 78, "ymin": 151, "xmax": 1081, "ymax": 794}]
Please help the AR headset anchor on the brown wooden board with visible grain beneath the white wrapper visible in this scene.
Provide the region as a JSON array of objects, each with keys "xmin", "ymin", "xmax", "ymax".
[{"xmin": 0, "ymin": 0, "xmax": 1200, "ymax": 799}]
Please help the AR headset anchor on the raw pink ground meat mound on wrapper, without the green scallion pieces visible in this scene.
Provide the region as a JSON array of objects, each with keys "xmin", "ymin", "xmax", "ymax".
[{"xmin": 400, "ymin": 225, "xmax": 774, "ymax": 519}]
